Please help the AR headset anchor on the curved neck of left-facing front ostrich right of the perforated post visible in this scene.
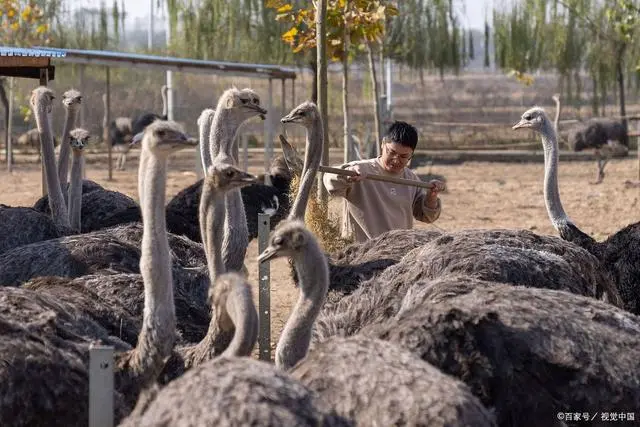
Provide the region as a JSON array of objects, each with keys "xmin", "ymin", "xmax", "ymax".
[{"xmin": 276, "ymin": 242, "xmax": 329, "ymax": 370}]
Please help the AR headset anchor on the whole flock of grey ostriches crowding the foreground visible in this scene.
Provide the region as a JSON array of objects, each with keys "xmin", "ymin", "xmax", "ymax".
[{"xmin": 0, "ymin": 87, "xmax": 640, "ymax": 427}]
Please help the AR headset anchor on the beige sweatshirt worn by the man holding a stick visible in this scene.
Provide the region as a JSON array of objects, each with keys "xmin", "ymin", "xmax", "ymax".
[{"xmin": 323, "ymin": 159, "xmax": 441, "ymax": 242}]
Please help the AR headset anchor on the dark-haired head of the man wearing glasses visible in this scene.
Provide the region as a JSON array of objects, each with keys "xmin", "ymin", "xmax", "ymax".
[{"xmin": 380, "ymin": 121, "xmax": 418, "ymax": 173}]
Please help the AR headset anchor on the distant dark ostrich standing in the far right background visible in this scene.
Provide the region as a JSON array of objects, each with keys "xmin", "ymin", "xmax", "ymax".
[{"xmin": 568, "ymin": 119, "xmax": 629, "ymax": 184}]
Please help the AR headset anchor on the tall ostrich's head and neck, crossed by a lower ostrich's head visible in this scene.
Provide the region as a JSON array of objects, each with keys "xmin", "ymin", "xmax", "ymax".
[{"xmin": 207, "ymin": 88, "xmax": 267, "ymax": 271}]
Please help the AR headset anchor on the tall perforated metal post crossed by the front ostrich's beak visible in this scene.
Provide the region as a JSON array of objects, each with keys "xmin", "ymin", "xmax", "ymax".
[{"xmin": 258, "ymin": 213, "xmax": 271, "ymax": 361}]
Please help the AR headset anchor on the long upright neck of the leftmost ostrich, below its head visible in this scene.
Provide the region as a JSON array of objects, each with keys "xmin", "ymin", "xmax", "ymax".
[{"xmin": 34, "ymin": 105, "xmax": 70, "ymax": 229}]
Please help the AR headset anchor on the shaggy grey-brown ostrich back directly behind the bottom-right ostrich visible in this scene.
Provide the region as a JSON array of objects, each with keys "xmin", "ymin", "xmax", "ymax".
[{"xmin": 313, "ymin": 229, "xmax": 621, "ymax": 342}]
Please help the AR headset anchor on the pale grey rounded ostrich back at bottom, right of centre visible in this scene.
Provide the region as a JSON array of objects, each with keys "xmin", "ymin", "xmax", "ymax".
[{"xmin": 290, "ymin": 336, "xmax": 496, "ymax": 427}]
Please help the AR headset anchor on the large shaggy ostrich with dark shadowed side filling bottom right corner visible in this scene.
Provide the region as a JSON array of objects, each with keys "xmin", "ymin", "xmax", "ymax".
[{"xmin": 361, "ymin": 275, "xmax": 640, "ymax": 427}]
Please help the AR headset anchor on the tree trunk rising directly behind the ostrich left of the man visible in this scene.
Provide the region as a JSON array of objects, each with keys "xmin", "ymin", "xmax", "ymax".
[{"xmin": 316, "ymin": 0, "xmax": 329, "ymax": 204}]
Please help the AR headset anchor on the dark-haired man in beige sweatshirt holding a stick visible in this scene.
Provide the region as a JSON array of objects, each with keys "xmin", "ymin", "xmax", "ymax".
[{"xmin": 323, "ymin": 121, "xmax": 444, "ymax": 242}]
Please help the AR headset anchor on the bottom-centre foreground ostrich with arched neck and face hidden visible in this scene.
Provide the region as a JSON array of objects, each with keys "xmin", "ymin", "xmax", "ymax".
[{"xmin": 121, "ymin": 273, "xmax": 351, "ymax": 427}]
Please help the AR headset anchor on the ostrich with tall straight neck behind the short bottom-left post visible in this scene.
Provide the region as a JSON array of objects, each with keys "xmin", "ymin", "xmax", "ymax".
[{"xmin": 0, "ymin": 118, "xmax": 195, "ymax": 426}]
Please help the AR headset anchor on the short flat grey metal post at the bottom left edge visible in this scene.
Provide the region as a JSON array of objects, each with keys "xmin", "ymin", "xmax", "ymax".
[{"xmin": 89, "ymin": 346, "xmax": 113, "ymax": 427}]
